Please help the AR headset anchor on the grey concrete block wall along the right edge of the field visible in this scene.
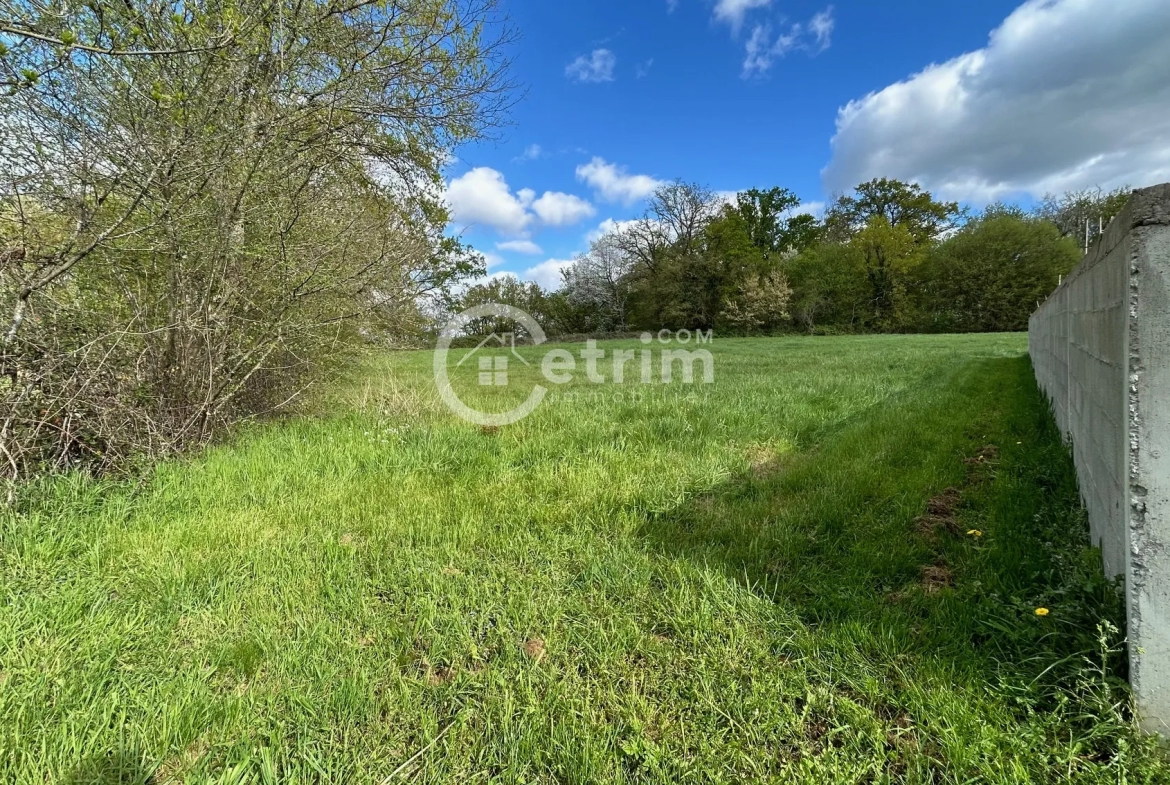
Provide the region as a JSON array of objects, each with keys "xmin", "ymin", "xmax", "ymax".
[{"xmin": 1028, "ymin": 184, "xmax": 1170, "ymax": 736}]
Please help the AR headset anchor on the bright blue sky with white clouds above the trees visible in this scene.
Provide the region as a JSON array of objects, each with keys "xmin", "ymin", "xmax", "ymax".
[{"xmin": 447, "ymin": 0, "xmax": 1170, "ymax": 287}]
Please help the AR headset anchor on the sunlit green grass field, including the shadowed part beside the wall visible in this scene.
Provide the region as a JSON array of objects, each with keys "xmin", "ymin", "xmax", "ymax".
[{"xmin": 0, "ymin": 335, "xmax": 1168, "ymax": 783}]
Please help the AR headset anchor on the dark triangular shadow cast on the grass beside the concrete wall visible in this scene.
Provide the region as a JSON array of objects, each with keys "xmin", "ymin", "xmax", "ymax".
[{"xmin": 641, "ymin": 357, "xmax": 1124, "ymax": 683}]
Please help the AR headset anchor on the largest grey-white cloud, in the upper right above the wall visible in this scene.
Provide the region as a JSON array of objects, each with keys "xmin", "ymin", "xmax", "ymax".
[{"xmin": 821, "ymin": 0, "xmax": 1170, "ymax": 202}]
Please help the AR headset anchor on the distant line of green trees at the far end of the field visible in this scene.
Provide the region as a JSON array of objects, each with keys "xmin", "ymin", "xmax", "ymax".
[{"xmin": 457, "ymin": 179, "xmax": 1129, "ymax": 335}]
